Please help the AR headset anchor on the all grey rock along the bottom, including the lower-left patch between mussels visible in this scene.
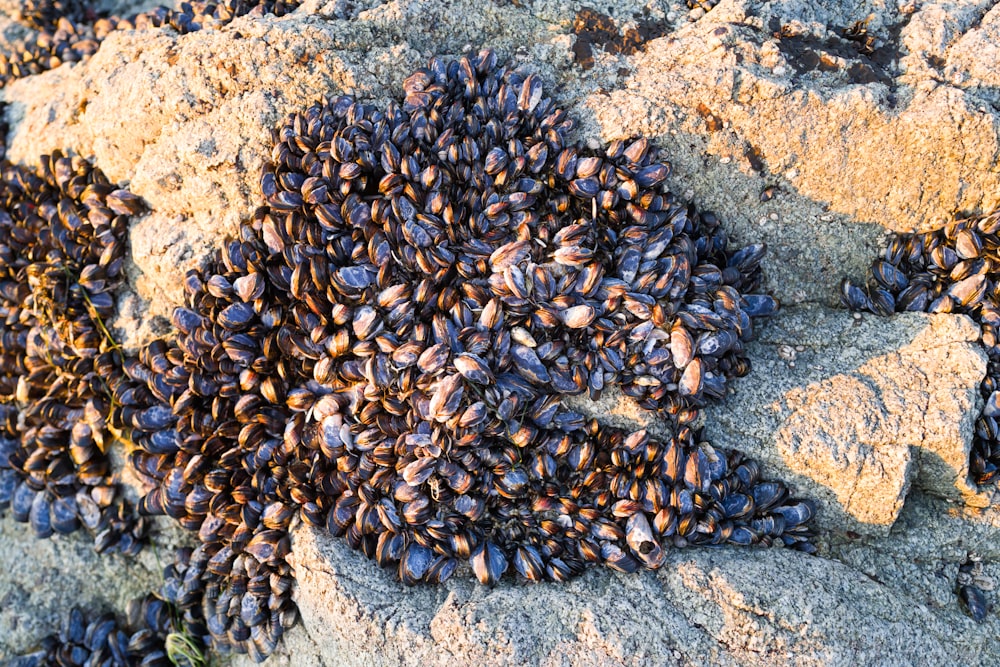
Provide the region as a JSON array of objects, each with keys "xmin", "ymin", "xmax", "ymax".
[{"xmin": 0, "ymin": 494, "xmax": 1000, "ymax": 666}]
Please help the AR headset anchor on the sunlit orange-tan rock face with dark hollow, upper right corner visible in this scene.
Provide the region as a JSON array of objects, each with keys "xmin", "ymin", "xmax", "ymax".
[{"xmin": 594, "ymin": 1, "xmax": 997, "ymax": 235}]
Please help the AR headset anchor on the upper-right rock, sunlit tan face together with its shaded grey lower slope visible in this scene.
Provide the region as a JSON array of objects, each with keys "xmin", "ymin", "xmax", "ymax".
[{"xmin": 580, "ymin": 1, "xmax": 1000, "ymax": 302}]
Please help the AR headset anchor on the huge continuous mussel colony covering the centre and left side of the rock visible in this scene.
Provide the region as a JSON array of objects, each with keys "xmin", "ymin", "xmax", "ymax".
[{"xmin": 0, "ymin": 3, "xmax": 814, "ymax": 664}]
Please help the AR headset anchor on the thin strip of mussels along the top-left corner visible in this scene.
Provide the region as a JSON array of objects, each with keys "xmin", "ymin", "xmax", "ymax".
[{"xmin": 0, "ymin": 0, "xmax": 301, "ymax": 87}]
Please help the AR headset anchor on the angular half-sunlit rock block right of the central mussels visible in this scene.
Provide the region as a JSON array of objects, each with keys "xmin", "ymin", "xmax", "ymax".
[{"xmin": 704, "ymin": 308, "xmax": 988, "ymax": 533}]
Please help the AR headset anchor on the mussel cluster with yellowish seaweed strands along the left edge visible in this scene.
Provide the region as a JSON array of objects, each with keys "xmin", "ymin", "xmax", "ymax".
[{"xmin": 0, "ymin": 140, "xmax": 145, "ymax": 554}]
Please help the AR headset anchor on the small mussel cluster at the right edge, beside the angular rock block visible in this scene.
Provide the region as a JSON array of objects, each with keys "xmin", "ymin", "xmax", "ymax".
[{"xmin": 841, "ymin": 211, "xmax": 1000, "ymax": 485}]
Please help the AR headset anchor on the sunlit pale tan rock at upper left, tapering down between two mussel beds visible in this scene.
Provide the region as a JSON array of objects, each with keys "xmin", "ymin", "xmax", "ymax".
[{"xmin": 4, "ymin": 2, "xmax": 556, "ymax": 347}]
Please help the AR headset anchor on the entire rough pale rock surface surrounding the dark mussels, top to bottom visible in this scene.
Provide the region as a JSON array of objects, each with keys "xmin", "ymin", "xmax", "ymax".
[{"xmin": 0, "ymin": 0, "xmax": 1000, "ymax": 665}]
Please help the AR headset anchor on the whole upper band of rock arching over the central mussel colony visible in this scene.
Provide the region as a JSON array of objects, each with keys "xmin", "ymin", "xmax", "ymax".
[{"xmin": 4, "ymin": 0, "xmax": 1000, "ymax": 324}]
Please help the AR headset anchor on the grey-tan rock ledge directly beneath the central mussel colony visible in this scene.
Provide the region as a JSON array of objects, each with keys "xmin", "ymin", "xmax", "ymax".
[{"xmin": 278, "ymin": 508, "xmax": 1000, "ymax": 666}]
